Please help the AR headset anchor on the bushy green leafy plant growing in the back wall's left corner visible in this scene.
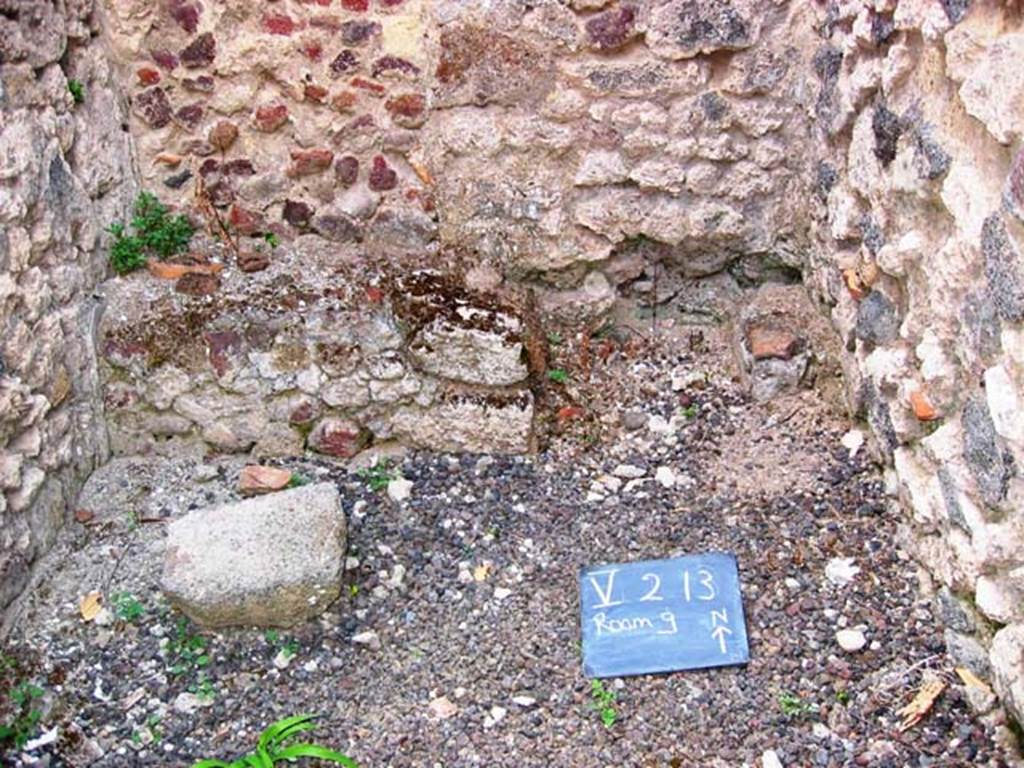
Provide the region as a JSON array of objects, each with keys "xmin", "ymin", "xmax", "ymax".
[{"xmin": 106, "ymin": 191, "xmax": 196, "ymax": 274}]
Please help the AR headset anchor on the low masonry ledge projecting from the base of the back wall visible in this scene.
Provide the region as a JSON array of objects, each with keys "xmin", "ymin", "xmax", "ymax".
[{"xmin": 100, "ymin": 262, "xmax": 536, "ymax": 458}]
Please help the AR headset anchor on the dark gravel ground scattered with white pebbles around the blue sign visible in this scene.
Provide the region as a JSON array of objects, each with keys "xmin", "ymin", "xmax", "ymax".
[{"xmin": 5, "ymin": 315, "xmax": 1016, "ymax": 768}]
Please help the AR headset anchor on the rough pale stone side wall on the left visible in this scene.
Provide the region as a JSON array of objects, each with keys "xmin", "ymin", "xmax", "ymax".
[{"xmin": 0, "ymin": 0, "xmax": 133, "ymax": 608}]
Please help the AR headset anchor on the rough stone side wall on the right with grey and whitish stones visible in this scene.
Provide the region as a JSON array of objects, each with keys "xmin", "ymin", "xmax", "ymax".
[{"xmin": 806, "ymin": 0, "xmax": 1024, "ymax": 733}]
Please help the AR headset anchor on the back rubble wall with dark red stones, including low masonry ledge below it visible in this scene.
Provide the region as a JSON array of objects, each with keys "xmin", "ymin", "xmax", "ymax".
[{"xmin": 94, "ymin": 0, "xmax": 813, "ymax": 455}]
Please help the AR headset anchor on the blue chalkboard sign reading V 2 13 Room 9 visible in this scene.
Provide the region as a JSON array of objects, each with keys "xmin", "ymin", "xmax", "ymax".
[{"xmin": 580, "ymin": 553, "xmax": 751, "ymax": 677}]
